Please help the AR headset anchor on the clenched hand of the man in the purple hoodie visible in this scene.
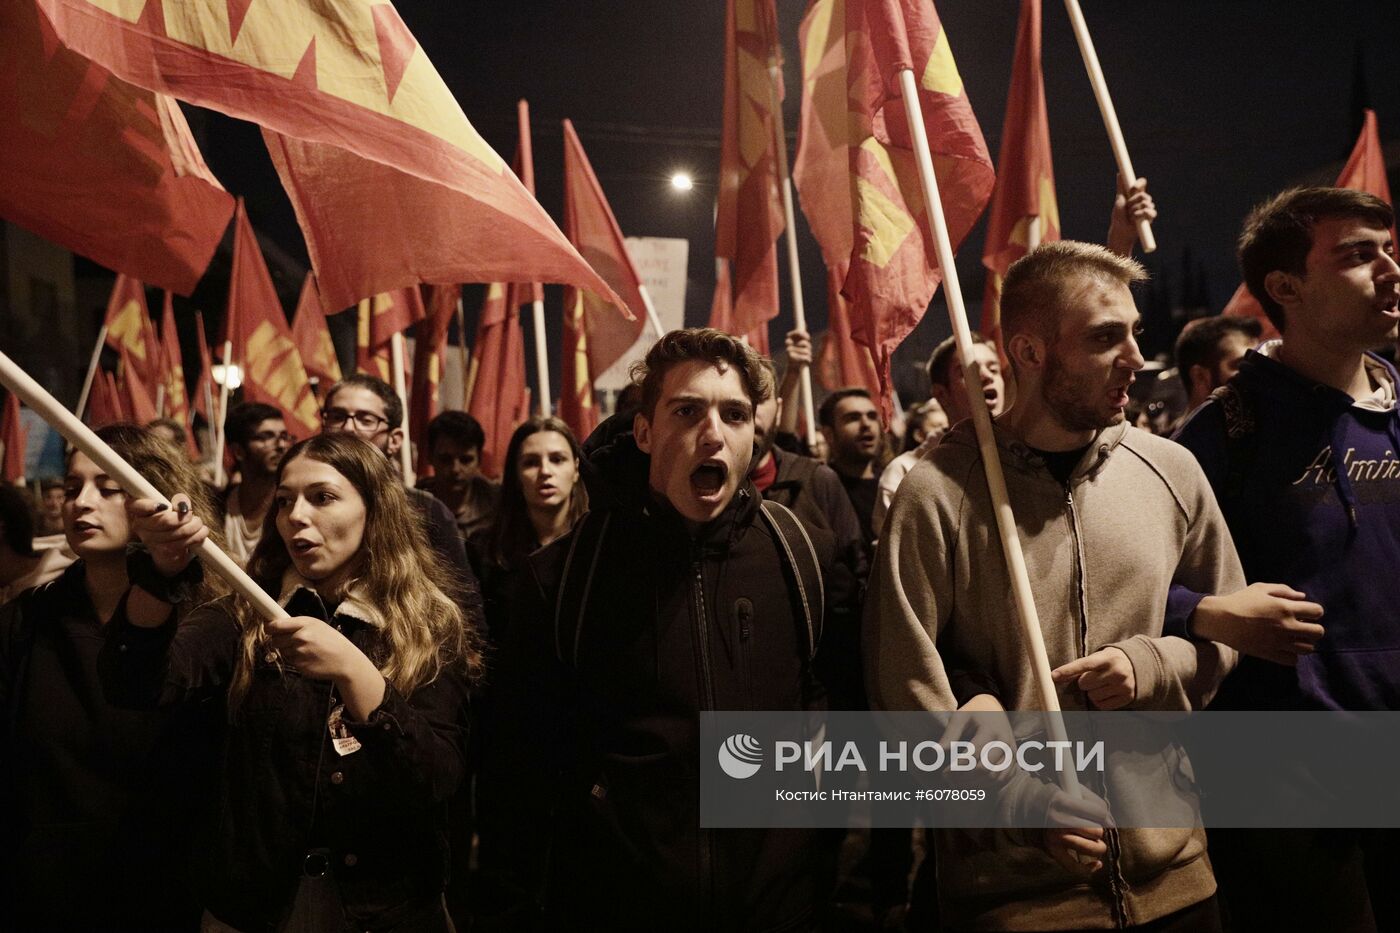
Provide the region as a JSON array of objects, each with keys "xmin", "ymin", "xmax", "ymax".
[{"xmin": 1187, "ymin": 583, "xmax": 1323, "ymax": 667}]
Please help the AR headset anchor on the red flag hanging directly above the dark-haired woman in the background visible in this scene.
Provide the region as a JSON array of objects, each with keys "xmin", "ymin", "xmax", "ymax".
[{"xmin": 468, "ymin": 283, "xmax": 532, "ymax": 479}]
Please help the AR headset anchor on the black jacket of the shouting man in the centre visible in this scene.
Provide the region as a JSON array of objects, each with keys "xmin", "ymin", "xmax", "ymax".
[{"xmin": 487, "ymin": 436, "xmax": 818, "ymax": 930}]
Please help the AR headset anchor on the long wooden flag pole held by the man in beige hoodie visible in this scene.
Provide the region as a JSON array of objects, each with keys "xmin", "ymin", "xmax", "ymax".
[{"xmin": 899, "ymin": 69, "xmax": 1079, "ymax": 796}]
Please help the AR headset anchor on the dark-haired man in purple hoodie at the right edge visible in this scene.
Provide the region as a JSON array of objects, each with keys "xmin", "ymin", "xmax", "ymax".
[{"xmin": 1177, "ymin": 188, "xmax": 1400, "ymax": 930}]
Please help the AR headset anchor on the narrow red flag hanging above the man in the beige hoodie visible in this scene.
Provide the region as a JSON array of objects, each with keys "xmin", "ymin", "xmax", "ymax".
[{"xmin": 981, "ymin": 0, "xmax": 1060, "ymax": 347}]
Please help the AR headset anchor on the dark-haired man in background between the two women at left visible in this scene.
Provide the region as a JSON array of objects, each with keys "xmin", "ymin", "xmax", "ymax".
[{"xmin": 224, "ymin": 402, "xmax": 294, "ymax": 566}]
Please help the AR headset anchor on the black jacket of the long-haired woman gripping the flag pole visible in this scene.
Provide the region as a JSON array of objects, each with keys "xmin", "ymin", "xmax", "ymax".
[{"xmin": 101, "ymin": 577, "xmax": 468, "ymax": 933}]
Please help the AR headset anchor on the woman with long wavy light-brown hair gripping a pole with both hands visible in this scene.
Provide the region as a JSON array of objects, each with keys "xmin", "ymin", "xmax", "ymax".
[{"xmin": 104, "ymin": 434, "xmax": 480, "ymax": 932}]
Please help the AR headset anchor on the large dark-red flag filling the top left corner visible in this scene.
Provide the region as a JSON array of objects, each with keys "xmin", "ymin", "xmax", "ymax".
[{"xmin": 0, "ymin": 3, "xmax": 234, "ymax": 294}]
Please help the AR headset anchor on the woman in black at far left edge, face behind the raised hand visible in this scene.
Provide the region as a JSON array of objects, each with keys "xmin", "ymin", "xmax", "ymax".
[{"xmin": 0, "ymin": 424, "xmax": 224, "ymax": 930}]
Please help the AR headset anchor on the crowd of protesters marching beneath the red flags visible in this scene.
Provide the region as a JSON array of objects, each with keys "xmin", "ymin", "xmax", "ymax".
[{"xmin": 0, "ymin": 184, "xmax": 1400, "ymax": 933}]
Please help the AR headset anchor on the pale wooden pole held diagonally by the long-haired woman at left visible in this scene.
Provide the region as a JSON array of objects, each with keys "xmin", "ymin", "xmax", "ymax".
[{"xmin": 0, "ymin": 353, "xmax": 287, "ymax": 619}]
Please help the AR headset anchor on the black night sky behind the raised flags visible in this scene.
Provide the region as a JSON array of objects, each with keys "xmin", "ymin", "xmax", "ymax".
[{"xmin": 192, "ymin": 0, "xmax": 1400, "ymax": 392}]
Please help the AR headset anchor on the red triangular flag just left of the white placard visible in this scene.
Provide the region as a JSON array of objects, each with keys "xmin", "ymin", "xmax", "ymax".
[{"xmin": 563, "ymin": 120, "xmax": 647, "ymax": 409}]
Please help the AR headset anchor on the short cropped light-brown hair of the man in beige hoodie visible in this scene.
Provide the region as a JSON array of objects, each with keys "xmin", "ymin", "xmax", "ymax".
[{"xmin": 1001, "ymin": 240, "xmax": 1147, "ymax": 338}]
